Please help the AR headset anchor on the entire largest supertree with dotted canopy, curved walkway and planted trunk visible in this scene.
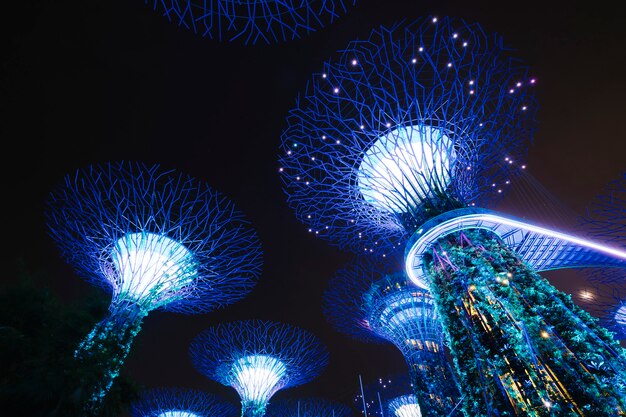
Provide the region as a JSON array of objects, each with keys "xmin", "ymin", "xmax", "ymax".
[{"xmin": 279, "ymin": 18, "xmax": 626, "ymax": 416}]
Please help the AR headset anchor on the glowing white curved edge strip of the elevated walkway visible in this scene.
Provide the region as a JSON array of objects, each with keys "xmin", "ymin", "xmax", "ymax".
[{"xmin": 405, "ymin": 213, "xmax": 626, "ymax": 288}]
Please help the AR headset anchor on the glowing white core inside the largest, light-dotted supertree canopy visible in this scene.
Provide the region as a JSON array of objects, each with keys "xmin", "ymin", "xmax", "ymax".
[{"xmin": 358, "ymin": 125, "xmax": 456, "ymax": 213}]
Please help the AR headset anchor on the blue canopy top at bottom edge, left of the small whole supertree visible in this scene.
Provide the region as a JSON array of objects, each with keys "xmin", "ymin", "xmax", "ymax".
[{"xmin": 131, "ymin": 388, "xmax": 238, "ymax": 417}]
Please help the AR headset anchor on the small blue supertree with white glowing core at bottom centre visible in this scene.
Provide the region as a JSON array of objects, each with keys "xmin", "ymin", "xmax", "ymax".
[{"xmin": 190, "ymin": 320, "xmax": 328, "ymax": 417}]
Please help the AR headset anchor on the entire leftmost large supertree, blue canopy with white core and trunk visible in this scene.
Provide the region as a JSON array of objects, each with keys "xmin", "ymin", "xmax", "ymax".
[{"xmin": 46, "ymin": 161, "xmax": 262, "ymax": 413}]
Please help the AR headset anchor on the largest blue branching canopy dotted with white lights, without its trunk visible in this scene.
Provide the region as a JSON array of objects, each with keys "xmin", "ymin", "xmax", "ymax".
[{"xmin": 279, "ymin": 18, "xmax": 536, "ymax": 254}]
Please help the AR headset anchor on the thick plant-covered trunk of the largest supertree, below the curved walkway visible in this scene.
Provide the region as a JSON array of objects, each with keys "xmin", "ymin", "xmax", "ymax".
[{"xmin": 425, "ymin": 229, "xmax": 626, "ymax": 417}]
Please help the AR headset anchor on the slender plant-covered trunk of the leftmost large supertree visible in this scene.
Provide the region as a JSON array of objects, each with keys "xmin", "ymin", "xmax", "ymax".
[{"xmin": 74, "ymin": 303, "xmax": 146, "ymax": 416}]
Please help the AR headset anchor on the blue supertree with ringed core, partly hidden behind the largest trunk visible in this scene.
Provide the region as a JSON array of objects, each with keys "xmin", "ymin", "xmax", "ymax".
[{"xmin": 323, "ymin": 257, "xmax": 459, "ymax": 416}]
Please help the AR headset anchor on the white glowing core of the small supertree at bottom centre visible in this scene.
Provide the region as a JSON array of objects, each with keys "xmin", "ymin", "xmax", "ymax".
[{"xmin": 231, "ymin": 355, "xmax": 287, "ymax": 404}]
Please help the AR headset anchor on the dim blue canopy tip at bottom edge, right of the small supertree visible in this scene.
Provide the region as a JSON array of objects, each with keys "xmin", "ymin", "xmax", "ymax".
[{"xmin": 266, "ymin": 398, "xmax": 354, "ymax": 417}]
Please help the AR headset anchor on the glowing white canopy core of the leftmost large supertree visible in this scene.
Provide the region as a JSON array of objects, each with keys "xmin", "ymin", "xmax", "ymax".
[{"xmin": 111, "ymin": 233, "xmax": 197, "ymax": 300}]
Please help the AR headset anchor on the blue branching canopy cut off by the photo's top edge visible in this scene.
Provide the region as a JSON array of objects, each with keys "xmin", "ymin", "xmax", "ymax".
[{"xmin": 144, "ymin": 0, "xmax": 356, "ymax": 44}]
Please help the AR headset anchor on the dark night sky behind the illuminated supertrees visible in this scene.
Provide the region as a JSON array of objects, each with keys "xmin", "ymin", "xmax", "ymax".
[{"xmin": 0, "ymin": 0, "xmax": 626, "ymax": 412}]
